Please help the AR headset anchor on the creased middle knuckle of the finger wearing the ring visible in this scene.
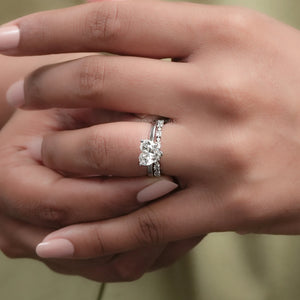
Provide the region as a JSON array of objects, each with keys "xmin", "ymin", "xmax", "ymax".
[{"xmin": 86, "ymin": 128, "xmax": 109, "ymax": 175}]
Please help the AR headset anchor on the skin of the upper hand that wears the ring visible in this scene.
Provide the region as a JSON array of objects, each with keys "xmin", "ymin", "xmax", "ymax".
[{"xmin": 2, "ymin": 1, "xmax": 300, "ymax": 280}]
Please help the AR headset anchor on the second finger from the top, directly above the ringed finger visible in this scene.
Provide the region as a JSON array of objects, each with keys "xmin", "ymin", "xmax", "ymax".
[{"xmin": 7, "ymin": 55, "xmax": 183, "ymax": 118}]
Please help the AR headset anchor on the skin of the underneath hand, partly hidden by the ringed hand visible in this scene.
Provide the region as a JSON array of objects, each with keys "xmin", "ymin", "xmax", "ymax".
[{"xmin": 0, "ymin": 54, "xmax": 202, "ymax": 282}]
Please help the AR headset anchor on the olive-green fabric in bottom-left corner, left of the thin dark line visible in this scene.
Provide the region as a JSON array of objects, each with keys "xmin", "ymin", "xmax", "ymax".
[{"xmin": 0, "ymin": 254, "xmax": 100, "ymax": 300}]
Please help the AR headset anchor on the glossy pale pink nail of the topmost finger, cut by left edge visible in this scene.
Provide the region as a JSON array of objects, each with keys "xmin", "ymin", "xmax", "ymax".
[{"xmin": 0, "ymin": 25, "xmax": 20, "ymax": 51}]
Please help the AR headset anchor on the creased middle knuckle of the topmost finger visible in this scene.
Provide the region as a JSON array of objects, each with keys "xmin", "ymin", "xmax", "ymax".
[{"xmin": 84, "ymin": 2, "xmax": 122, "ymax": 44}]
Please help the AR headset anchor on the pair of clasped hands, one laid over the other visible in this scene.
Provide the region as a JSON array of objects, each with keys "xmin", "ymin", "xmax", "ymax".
[{"xmin": 0, "ymin": 1, "xmax": 300, "ymax": 281}]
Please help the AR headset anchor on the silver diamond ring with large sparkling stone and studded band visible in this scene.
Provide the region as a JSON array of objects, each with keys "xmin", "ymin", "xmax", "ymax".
[{"xmin": 139, "ymin": 120, "xmax": 165, "ymax": 177}]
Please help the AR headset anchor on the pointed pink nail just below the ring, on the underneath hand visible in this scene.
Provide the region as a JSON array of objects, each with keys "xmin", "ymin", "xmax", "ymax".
[{"xmin": 137, "ymin": 179, "xmax": 178, "ymax": 202}]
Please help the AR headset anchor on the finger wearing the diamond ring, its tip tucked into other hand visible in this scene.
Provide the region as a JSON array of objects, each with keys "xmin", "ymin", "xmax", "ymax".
[{"xmin": 41, "ymin": 122, "xmax": 188, "ymax": 177}]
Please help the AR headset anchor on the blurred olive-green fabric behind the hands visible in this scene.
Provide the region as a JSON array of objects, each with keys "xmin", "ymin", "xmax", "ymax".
[{"xmin": 0, "ymin": 0, "xmax": 300, "ymax": 300}]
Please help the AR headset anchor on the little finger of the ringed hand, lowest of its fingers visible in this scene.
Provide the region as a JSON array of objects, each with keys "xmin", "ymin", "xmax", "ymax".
[{"xmin": 38, "ymin": 187, "xmax": 229, "ymax": 258}]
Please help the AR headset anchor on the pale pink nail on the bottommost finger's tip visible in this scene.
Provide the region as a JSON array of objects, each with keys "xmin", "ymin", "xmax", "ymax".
[{"xmin": 36, "ymin": 239, "xmax": 75, "ymax": 258}]
